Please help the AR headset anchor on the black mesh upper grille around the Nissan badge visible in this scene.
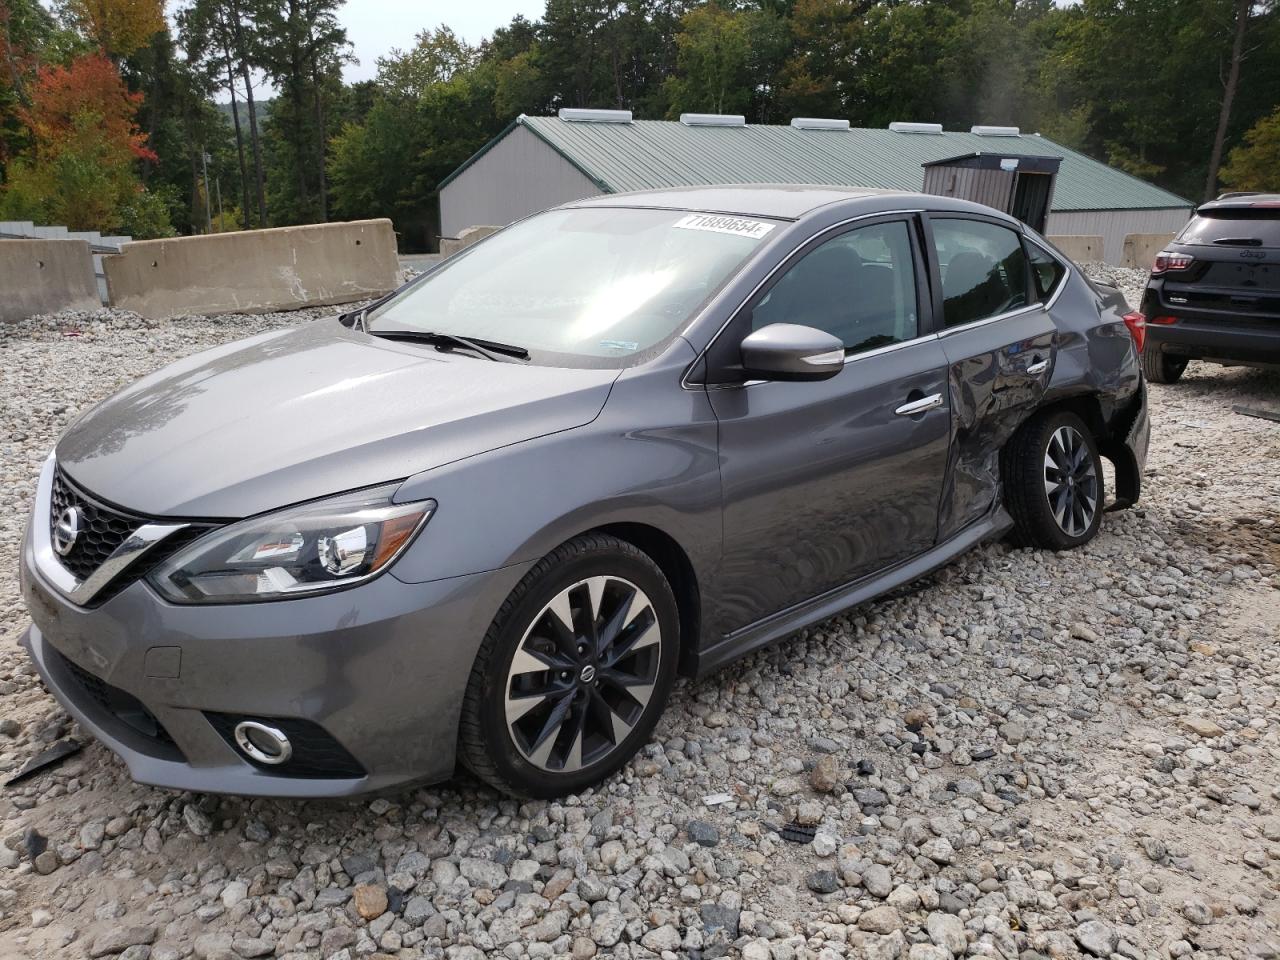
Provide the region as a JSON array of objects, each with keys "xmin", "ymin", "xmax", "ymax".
[{"xmin": 49, "ymin": 467, "xmax": 215, "ymax": 607}]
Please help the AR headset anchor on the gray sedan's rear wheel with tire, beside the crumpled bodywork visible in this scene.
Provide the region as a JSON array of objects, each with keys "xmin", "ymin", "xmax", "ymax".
[{"xmin": 1001, "ymin": 411, "xmax": 1105, "ymax": 550}]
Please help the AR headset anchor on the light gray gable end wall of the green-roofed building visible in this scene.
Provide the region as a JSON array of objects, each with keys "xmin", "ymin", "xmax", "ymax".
[{"xmin": 440, "ymin": 125, "xmax": 602, "ymax": 237}]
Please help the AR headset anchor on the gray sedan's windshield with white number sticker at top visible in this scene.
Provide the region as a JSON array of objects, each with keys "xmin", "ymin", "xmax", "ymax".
[{"xmin": 365, "ymin": 207, "xmax": 776, "ymax": 366}]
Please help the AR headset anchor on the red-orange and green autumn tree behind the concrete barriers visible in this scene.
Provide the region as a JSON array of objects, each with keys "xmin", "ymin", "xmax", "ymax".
[{"xmin": 0, "ymin": 54, "xmax": 168, "ymax": 236}]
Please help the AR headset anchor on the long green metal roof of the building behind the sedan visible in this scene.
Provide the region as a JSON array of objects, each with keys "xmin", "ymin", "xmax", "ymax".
[{"xmin": 460, "ymin": 116, "xmax": 1193, "ymax": 211}]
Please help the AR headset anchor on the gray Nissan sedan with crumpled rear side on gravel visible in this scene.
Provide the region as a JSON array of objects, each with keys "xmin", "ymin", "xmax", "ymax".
[{"xmin": 22, "ymin": 186, "xmax": 1148, "ymax": 797}]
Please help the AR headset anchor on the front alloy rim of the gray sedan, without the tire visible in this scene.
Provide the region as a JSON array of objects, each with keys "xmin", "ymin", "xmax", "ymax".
[{"xmin": 504, "ymin": 576, "xmax": 662, "ymax": 773}]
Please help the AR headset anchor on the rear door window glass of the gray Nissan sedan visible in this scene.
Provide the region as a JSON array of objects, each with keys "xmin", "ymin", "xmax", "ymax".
[{"xmin": 931, "ymin": 218, "xmax": 1027, "ymax": 326}]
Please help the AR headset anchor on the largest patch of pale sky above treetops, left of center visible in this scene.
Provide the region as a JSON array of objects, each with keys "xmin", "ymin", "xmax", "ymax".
[{"xmin": 338, "ymin": 0, "xmax": 545, "ymax": 82}]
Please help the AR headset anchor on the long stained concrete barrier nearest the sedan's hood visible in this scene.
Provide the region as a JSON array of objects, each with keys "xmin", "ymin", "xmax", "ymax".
[{"xmin": 102, "ymin": 220, "xmax": 399, "ymax": 320}]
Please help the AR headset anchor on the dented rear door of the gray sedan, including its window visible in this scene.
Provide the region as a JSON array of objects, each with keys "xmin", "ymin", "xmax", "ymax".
[{"xmin": 927, "ymin": 212, "xmax": 1057, "ymax": 540}]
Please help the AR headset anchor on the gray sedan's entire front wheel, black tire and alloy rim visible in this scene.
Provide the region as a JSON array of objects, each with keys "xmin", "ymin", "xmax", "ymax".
[{"xmin": 458, "ymin": 534, "xmax": 680, "ymax": 799}]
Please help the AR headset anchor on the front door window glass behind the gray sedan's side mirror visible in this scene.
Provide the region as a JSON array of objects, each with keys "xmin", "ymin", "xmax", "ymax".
[{"xmin": 751, "ymin": 220, "xmax": 919, "ymax": 352}]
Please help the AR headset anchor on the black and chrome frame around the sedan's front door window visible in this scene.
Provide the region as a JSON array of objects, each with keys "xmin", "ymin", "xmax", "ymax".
[{"xmin": 680, "ymin": 209, "xmax": 936, "ymax": 389}]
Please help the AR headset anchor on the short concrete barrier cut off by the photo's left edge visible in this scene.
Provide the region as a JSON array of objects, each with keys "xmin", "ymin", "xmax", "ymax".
[{"xmin": 0, "ymin": 239, "xmax": 102, "ymax": 321}]
